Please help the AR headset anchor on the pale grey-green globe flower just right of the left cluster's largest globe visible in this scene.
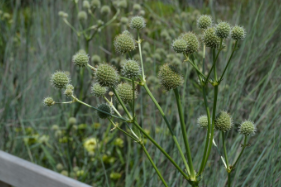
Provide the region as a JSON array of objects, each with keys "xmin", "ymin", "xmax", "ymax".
[{"xmin": 122, "ymin": 60, "xmax": 140, "ymax": 79}]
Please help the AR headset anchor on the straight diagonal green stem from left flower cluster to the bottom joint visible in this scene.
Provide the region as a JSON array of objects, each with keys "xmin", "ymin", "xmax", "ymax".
[{"xmin": 133, "ymin": 121, "xmax": 189, "ymax": 180}]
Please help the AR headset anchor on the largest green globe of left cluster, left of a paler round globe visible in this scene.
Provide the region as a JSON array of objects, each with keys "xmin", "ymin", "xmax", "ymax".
[{"xmin": 96, "ymin": 64, "xmax": 119, "ymax": 87}]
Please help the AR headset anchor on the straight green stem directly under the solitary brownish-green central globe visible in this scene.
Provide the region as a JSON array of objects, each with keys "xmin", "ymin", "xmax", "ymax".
[{"xmin": 174, "ymin": 88, "xmax": 196, "ymax": 180}]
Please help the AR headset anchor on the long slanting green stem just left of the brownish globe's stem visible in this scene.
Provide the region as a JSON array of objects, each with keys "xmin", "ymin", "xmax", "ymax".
[{"xmin": 143, "ymin": 84, "xmax": 190, "ymax": 175}]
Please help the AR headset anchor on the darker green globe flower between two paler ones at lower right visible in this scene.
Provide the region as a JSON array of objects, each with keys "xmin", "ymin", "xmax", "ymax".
[{"xmin": 215, "ymin": 111, "xmax": 232, "ymax": 132}]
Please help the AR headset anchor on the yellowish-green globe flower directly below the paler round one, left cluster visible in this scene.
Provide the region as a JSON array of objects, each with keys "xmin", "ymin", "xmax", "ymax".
[{"xmin": 116, "ymin": 83, "xmax": 136, "ymax": 103}]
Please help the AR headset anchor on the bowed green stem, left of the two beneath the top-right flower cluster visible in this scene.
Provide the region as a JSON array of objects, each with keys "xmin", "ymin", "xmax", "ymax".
[{"xmin": 198, "ymin": 86, "xmax": 211, "ymax": 175}]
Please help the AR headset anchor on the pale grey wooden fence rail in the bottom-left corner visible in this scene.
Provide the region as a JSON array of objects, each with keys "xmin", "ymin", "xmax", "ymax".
[{"xmin": 0, "ymin": 151, "xmax": 90, "ymax": 187}]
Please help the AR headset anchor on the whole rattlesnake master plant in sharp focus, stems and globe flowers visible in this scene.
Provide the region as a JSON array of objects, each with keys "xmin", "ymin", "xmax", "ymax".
[{"xmin": 44, "ymin": 13, "xmax": 256, "ymax": 186}]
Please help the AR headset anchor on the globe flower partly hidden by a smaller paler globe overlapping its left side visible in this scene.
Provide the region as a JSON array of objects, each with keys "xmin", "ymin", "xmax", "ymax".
[{"xmin": 180, "ymin": 32, "xmax": 199, "ymax": 54}]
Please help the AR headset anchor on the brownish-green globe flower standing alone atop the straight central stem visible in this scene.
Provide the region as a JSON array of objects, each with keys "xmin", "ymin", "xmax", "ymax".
[{"xmin": 158, "ymin": 64, "xmax": 183, "ymax": 90}]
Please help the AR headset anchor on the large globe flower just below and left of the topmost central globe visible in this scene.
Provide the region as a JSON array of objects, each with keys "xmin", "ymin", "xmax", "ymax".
[{"xmin": 114, "ymin": 33, "xmax": 136, "ymax": 54}]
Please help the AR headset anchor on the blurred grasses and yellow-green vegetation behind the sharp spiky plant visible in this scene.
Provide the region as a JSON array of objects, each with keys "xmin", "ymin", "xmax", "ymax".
[{"xmin": 0, "ymin": 0, "xmax": 281, "ymax": 186}]
